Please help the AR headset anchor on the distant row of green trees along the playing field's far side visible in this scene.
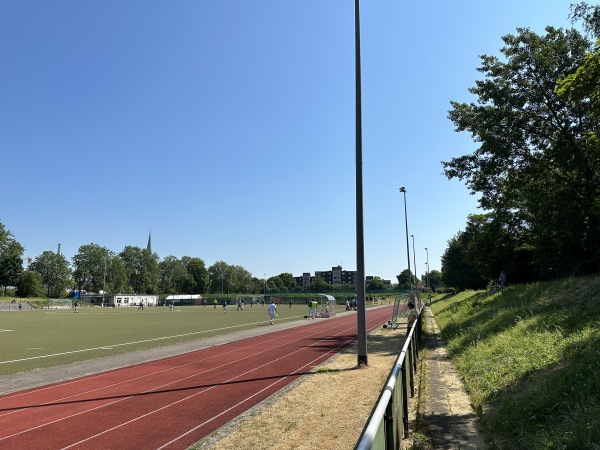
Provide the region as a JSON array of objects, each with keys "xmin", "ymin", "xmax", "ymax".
[{"xmin": 0, "ymin": 222, "xmax": 420, "ymax": 298}]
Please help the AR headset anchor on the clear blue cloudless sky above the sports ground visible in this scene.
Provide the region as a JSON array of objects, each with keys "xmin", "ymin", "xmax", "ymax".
[{"xmin": 0, "ymin": 0, "xmax": 570, "ymax": 281}]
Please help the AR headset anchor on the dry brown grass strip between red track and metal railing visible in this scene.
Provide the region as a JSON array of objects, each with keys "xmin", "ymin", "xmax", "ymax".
[{"xmin": 194, "ymin": 328, "xmax": 405, "ymax": 450}]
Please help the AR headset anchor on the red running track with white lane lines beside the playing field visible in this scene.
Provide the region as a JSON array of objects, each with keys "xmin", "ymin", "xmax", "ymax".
[{"xmin": 0, "ymin": 307, "xmax": 392, "ymax": 450}]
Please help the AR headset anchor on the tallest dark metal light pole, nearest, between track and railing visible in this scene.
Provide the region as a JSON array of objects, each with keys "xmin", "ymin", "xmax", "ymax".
[{"xmin": 354, "ymin": 0, "xmax": 368, "ymax": 367}]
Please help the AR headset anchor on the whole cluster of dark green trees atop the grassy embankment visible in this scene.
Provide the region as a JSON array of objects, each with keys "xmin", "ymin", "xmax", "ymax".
[{"xmin": 442, "ymin": 3, "xmax": 600, "ymax": 288}]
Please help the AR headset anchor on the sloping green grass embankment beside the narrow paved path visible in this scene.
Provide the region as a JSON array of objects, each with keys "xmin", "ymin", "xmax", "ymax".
[{"xmin": 431, "ymin": 277, "xmax": 600, "ymax": 450}]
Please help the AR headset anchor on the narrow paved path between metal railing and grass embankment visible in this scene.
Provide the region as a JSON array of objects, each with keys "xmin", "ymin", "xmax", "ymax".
[{"xmin": 419, "ymin": 308, "xmax": 487, "ymax": 450}]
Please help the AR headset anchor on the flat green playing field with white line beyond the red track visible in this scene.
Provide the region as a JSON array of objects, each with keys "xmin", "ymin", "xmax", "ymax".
[{"xmin": 0, "ymin": 305, "xmax": 356, "ymax": 375}]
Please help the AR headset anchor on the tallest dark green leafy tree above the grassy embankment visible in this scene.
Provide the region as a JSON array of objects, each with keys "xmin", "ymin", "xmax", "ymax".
[{"xmin": 443, "ymin": 27, "xmax": 600, "ymax": 281}]
